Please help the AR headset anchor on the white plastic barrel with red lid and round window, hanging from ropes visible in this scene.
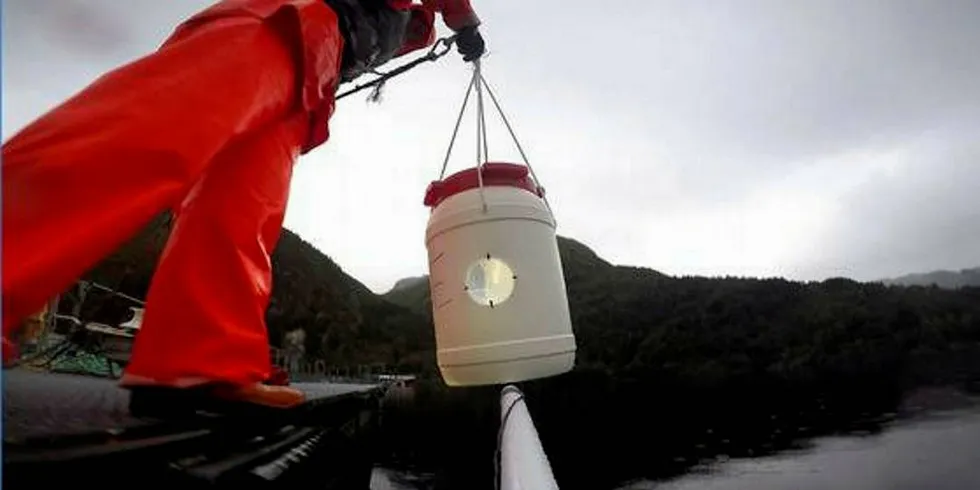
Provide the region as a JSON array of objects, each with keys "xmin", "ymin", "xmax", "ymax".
[{"xmin": 425, "ymin": 163, "xmax": 575, "ymax": 386}]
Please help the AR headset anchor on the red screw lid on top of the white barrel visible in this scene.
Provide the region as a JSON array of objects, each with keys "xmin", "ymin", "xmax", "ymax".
[{"xmin": 423, "ymin": 163, "xmax": 544, "ymax": 207}]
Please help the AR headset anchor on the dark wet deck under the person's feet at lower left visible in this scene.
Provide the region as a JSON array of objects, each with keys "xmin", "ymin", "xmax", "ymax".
[{"xmin": 3, "ymin": 369, "xmax": 381, "ymax": 488}]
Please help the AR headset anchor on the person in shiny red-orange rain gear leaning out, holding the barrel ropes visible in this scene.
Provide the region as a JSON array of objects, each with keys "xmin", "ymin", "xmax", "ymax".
[{"xmin": 2, "ymin": 0, "xmax": 485, "ymax": 407}]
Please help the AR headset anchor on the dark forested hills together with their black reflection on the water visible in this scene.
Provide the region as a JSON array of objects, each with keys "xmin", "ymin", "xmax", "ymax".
[{"xmin": 76, "ymin": 215, "xmax": 980, "ymax": 490}]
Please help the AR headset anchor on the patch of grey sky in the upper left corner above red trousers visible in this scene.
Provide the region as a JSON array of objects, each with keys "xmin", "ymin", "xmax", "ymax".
[{"xmin": 2, "ymin": 0, "xmax": 210, "ymax": 134}]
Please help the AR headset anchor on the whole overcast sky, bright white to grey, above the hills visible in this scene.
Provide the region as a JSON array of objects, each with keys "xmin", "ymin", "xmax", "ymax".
[{"xmin": 2, "ymin": 0, "xmax": 980, "ymax": 291}]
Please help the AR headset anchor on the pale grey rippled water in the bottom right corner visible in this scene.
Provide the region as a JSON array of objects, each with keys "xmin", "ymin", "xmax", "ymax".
[{"xmin": 622, "ymin": 410, "xmax": 980, "ymax": 490}]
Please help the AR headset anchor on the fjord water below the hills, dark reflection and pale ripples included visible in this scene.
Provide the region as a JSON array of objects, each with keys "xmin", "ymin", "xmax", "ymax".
[{"xmin": 376, "ymin": 379, "xmax": 980, "ymax": 490}]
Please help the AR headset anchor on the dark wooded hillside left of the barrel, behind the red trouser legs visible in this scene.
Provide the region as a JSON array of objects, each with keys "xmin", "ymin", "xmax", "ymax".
[{"xmin": 86, "ymin": 215, "xmax": 434, "ymax": 371}]
